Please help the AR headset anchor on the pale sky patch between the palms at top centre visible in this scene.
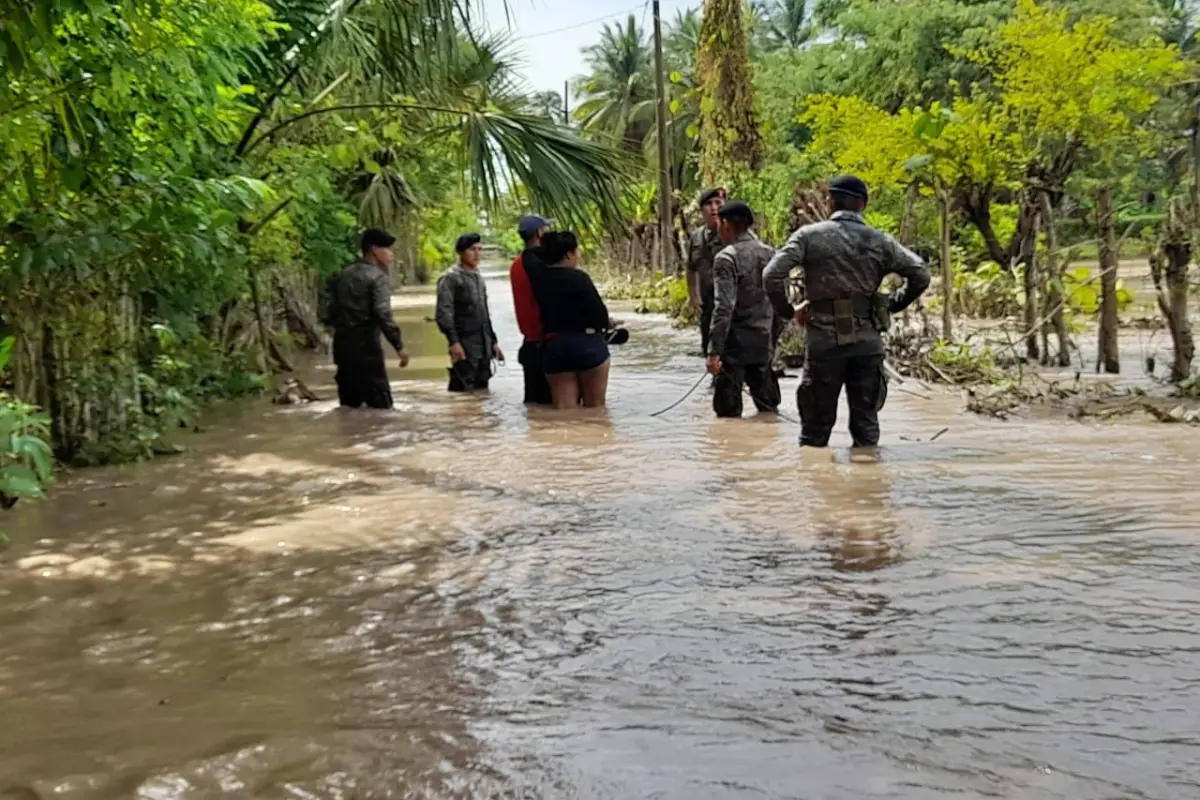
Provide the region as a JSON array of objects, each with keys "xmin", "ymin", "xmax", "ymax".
[{"xmin": 482, "ymin": 0, "xmax": 701, "ymax": 97}]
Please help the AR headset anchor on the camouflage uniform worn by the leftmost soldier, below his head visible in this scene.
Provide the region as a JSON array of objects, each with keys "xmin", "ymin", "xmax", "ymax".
[{"xmin": 325, "ymin": 261, "xmax": 404, "ymax": 408}]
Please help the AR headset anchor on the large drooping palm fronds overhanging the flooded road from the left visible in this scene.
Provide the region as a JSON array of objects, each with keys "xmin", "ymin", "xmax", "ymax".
[{"xmin": 236, "ymin": 0, "xmax": 622, "ymax": 221}]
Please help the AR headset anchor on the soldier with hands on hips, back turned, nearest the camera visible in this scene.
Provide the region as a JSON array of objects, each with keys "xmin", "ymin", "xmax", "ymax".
[{"xmin": 763, "ymin": 175, "xmax": 930, "ymax": 447}]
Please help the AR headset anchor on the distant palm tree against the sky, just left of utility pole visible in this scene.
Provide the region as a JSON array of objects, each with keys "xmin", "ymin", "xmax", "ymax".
[{"xmin": 575, "ymin": 14, "xmax": 654, "ymax": 152}]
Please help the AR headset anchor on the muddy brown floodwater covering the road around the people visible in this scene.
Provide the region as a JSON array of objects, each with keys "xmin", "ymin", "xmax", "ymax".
[{"xmin": 0, "ymin": 263, "xmax": 1200, "ymax": 800}]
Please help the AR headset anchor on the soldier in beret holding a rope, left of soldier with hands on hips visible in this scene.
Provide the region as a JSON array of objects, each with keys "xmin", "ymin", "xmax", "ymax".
[{"xmin": 708, "ymin": 201, "xmax": 780, "ymax": 417}]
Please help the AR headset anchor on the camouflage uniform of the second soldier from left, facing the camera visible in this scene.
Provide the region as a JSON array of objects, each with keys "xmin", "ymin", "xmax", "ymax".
[{"xmin": 437, "ymin": 264, "xmax": 496, "ymax": 392}]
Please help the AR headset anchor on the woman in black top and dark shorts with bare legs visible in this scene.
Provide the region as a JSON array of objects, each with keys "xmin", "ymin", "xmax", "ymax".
[{"xmin": 528, "ymin": 230, "xmax": 608, "ymax": 408}]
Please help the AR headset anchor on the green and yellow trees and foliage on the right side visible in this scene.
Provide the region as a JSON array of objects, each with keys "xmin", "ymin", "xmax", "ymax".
[{"xmin": 580, "ymin": 0, "xmax": 1200, "ymax": 380}]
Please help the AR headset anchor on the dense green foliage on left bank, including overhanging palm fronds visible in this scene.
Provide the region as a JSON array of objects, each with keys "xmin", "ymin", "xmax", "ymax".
[{"xmin": 0, "ymin": 0, "xmax": 622, "ymax": 463}]
